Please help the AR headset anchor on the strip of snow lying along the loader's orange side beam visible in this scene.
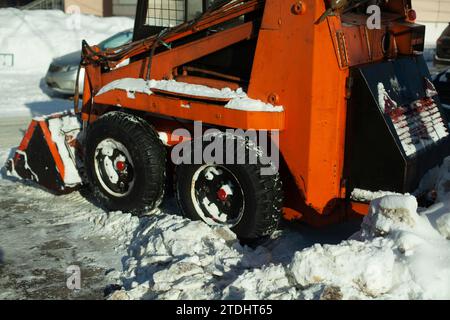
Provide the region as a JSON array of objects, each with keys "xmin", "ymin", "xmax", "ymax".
[{"xmin": 97, "ymin": 78, "xmax": 284, "ymax": 112}]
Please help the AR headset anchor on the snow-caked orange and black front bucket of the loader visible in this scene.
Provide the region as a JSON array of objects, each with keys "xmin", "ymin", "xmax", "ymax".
[{"xmin": 7, "ymin": 113, "xmax": 81, "ymax": 194}]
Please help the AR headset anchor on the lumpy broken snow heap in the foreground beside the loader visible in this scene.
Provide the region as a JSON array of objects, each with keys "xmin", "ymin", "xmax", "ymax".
[{"xmin": 92, "ymin": 159, "xmax": 450, "ymax": 300}]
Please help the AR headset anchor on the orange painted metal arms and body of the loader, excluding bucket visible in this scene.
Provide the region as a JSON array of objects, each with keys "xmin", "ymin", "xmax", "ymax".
[{"xmin": 78, "ymin": 0, "xmax": 414, "ymax": 225}]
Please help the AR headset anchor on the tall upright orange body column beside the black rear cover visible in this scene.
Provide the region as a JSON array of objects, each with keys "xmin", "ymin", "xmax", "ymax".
[{"xmin": 249, "ymin": 0, "xmax": 348, "ymax": 220}]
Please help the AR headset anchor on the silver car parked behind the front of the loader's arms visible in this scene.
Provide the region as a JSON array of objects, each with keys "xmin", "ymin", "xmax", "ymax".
[{"xmin": 45, "ymin": 29, "xmax": 133, "ymax": 95}]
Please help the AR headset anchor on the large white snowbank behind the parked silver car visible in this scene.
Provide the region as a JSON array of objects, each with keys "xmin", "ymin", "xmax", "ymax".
[{"xmin": 0, "ymin": 9, "xmax": 133, "ymax": 72}]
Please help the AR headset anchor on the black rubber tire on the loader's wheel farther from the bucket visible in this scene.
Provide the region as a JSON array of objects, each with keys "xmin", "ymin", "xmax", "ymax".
[{"xmin": 175, "ymin": 132, "xmax": 283, "ymax": 241}]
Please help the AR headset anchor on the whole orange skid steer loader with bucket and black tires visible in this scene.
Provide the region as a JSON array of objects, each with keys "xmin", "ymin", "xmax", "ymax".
[{"xmin": 7, "ymin": 0, "xmax": 450, "ymax": 239}]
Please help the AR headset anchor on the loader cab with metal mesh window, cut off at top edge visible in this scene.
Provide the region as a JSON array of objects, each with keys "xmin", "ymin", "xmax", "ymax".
[{"xmin": 133, "ymin": 0, "xmax": 212, "ymax": 41}]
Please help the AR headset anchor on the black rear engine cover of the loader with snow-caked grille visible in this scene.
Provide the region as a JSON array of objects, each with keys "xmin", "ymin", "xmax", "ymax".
[{"xmin": 345, "ymin": 56, "xmax": 450, "ymax": 193}]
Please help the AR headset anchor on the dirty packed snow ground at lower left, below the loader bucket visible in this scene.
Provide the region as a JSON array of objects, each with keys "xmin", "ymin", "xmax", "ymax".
[{"xmin": 0, "ymin": 149, "xmax": 133, "ymax": 300}]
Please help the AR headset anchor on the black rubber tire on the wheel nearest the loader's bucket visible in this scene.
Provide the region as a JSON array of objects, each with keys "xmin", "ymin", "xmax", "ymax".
[{"xmin": 84, "ymin": 112, "xmax": 166, "ymax": 215}]
